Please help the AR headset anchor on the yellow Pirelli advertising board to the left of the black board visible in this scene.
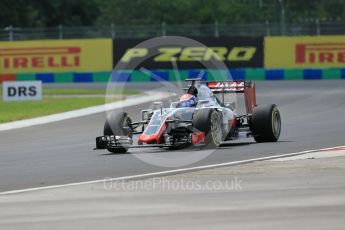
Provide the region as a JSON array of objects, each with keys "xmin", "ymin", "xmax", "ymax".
[{"xmin": 0, "ymin": 39, "xmax": 113, "ymax": 74}]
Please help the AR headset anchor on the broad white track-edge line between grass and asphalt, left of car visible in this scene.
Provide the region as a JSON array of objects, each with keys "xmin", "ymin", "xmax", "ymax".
[{"xmin": 0, "ymin": 91, "xmax": 171, "ymax": 131}]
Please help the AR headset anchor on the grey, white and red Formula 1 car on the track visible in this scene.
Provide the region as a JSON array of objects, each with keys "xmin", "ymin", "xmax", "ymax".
[{"xmin": 95, "ymin": 79, "xmax": 281, "ymax": 153}]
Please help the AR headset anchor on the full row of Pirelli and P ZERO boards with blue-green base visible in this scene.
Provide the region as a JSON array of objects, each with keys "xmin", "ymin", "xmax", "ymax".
[{"xmin": 0, "ymin": 36, "xmax": 345, "ymax": 84}]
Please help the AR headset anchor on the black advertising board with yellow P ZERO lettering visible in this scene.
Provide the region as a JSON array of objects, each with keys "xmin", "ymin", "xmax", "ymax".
[{"xmin": 113, "ymin": 37, "xmax": 263, "ymax": 69}]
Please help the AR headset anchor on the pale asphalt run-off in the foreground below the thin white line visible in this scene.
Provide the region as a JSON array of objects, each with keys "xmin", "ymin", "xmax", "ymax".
[{"xmin": 0, "ymin": 153, "xmax": 345, "ymax": 230}]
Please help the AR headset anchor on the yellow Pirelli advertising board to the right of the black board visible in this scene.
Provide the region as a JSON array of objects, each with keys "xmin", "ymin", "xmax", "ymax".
[{"xmin": 264, "ymin": 36, "xmax": 345, "ymax": 68}]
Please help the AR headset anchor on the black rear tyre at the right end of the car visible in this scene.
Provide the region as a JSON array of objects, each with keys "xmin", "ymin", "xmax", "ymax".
[{"xmin": 251, "ymin": 104, "xmax": 281, "ymax": 142}]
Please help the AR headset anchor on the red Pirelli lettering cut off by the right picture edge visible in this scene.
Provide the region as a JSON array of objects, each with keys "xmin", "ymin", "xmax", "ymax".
[{"xmin": 295, "ymin": 42, "xmax": 345, "ymax": 64}]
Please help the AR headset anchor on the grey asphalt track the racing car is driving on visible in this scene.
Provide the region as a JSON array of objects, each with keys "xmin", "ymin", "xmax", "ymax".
[{"xmin": 0, "ymin": 81, "xmax": 345, "ymax": 191}]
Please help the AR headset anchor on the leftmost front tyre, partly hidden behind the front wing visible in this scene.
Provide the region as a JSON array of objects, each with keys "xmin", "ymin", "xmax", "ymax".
[{"xmin": 103, "ymin": 112, "xmax": 133, "ymax": 153}]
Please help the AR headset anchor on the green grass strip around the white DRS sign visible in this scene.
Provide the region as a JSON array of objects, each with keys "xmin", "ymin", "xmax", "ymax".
[{"xmin": 0, "ymin": 85, "xmax": 142, "ymax": 123}]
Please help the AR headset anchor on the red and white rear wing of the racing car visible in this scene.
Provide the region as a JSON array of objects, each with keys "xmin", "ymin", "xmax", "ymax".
[{"xmin": 206, "ymin": 81, "xmax": 256, "ymax": 113}]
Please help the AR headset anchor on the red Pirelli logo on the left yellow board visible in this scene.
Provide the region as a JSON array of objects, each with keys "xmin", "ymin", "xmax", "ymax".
[{"xmin": 0, "ymin": 46, "xmax": 81, "ymax": 70}]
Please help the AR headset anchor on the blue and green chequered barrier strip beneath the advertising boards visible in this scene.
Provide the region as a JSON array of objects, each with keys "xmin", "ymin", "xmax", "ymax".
[{"xmin": 0, "ymin": 68, "xmax": 345, "ymax": 84}]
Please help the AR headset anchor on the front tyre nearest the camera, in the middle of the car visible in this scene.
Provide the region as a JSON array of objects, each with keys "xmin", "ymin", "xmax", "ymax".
[{"xmin": 192, "ymin": 109, "xmax": 223, "ymax": 148}]
